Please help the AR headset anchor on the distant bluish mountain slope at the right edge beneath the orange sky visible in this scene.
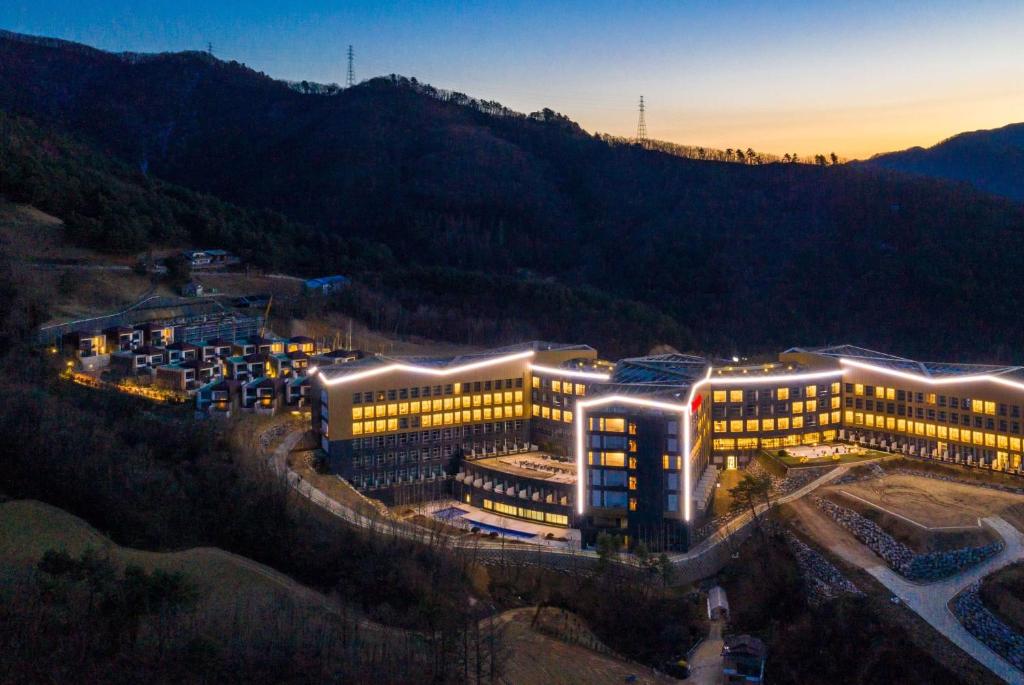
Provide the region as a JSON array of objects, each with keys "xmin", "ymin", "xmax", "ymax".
[{"xmin": 860, "ymin": 124, "xmax": 1024, "ymax": 201}]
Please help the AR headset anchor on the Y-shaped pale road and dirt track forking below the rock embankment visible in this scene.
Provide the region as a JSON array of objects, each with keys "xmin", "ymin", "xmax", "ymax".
[{"xmin": 798, "ymin": 503, "xmax": 1024, "ymax": 684}]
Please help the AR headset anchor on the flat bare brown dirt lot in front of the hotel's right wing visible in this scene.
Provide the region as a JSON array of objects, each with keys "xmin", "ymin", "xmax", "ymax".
[{"xmin": 819, "ymin": 473, "xmax": 1024, "ymax": 552}]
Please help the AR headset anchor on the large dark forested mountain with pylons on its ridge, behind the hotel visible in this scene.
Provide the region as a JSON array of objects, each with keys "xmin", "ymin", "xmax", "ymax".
[{"xmin": 6, "ymin": 29, "xmax": 1024, "ymax": 360}]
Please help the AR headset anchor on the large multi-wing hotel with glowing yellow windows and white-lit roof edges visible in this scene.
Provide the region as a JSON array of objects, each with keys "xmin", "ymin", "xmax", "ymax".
[{"xmin": 310, "ymin": 342, "xmax": 1024, "ymax": 549}]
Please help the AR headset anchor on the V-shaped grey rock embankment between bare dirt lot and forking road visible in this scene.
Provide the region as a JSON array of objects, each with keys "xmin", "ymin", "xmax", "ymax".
[{"xmin": 814, "ymin": 497, "xmax": 1002, "ymax": 583}]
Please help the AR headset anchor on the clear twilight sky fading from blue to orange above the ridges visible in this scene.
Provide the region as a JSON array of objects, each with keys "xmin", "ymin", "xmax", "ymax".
[{"xmin": 0, "ymin": 0, "xmax": 1024, "ymax": 158}]
